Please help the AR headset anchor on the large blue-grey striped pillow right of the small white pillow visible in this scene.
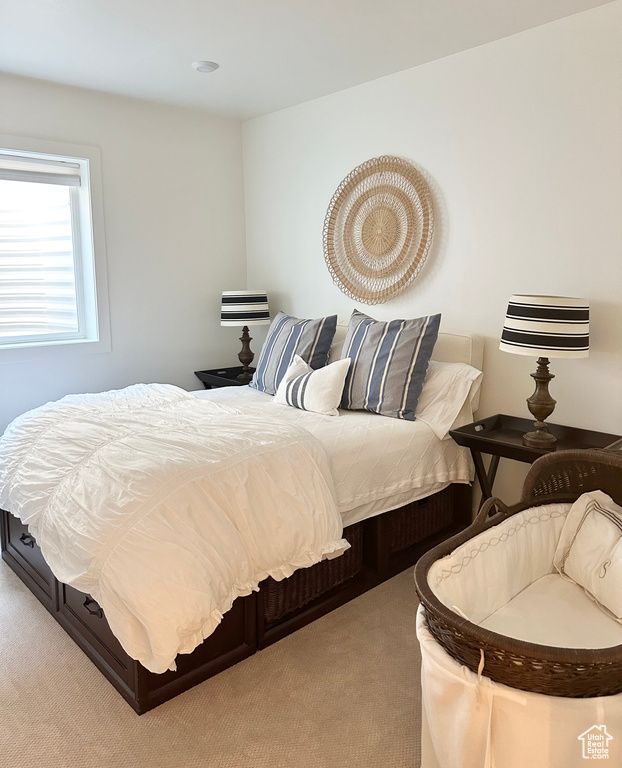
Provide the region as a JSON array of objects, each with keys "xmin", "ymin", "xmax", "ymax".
[{"xmin": 341, "ymin": 309, "xmax": 441, "ymax": 421}]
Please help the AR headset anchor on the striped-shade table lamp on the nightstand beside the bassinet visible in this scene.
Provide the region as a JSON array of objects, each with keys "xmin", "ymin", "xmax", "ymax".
[{"xmin": 499, "ymin": 295, "xmax": 590, "ymax": 451}]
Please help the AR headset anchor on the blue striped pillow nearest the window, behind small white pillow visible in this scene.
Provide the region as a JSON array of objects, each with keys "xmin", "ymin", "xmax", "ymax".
[{"xmin": 249, "ymin": 312, "xmax": 337, "ymax": 395}]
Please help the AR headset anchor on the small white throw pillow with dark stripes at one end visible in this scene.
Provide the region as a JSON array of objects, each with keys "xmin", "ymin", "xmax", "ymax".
[{"xmin": 274, "ymin": 355, "xmax": 350, "ymax": 416}]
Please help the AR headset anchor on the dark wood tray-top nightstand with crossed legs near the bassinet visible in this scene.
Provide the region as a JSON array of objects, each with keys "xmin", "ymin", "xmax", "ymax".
[{"xmin": 449, "ymin": 413, "xmax": 622, "ymax": 506}]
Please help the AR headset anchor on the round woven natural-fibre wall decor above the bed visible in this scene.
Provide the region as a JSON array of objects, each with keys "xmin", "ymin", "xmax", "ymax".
[{"xmin": 324, "ymin": 155, "xmax": 434, "ymax": 304}]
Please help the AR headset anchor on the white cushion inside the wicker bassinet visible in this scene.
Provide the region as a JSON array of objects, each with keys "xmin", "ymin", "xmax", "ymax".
[{"xmin": 553, "ymin": 491, "xmax": 622, "ymax": 623}]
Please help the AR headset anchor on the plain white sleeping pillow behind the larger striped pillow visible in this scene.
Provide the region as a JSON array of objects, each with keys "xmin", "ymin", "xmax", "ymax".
[{"xmin": 415, "ymin": 360, "xmax": 483, "ymax": 440}]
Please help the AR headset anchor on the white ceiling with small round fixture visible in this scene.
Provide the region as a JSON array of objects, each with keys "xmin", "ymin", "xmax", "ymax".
[{"xmin": 0, "ymin": 0, "xmax": 609, "ymax": 118}]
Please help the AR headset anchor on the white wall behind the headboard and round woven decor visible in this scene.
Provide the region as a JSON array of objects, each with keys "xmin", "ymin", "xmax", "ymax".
[{"xmin": 244, "ymin": 2, "xmax": 622, "ymax": 496}]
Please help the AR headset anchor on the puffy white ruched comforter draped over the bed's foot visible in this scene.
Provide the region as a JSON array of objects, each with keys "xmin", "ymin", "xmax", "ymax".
[{"xmin": 0, "ymin": 384, "xmax": 349, "ymax": 672}]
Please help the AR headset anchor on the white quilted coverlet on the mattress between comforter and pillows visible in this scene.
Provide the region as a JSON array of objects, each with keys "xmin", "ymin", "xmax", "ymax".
[{"xmin": 192, "ymin": 387, "xmax": 473, "ymax": 526}]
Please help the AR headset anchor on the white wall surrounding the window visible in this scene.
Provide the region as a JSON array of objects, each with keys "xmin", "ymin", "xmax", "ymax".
[{"xmin": 0, "ymin": 75, "xmax": 246, "ymax": 433}]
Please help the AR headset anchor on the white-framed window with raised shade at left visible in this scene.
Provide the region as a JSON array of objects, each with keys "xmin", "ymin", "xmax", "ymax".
[{"xmin": 0, "ymin": 137, "xmax": 107, "ymax": 359}]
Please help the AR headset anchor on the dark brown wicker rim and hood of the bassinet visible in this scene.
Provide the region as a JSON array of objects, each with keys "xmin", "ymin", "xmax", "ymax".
[{"xmin": 415, "ymin": 450, "xmax": 622, "ymax": 698}]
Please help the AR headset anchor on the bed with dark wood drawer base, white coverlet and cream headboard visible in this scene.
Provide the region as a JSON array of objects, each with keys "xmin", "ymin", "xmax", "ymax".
[{"xmin": 1, "ymin": 334, "xmax": 481, "ymax": 714}]
